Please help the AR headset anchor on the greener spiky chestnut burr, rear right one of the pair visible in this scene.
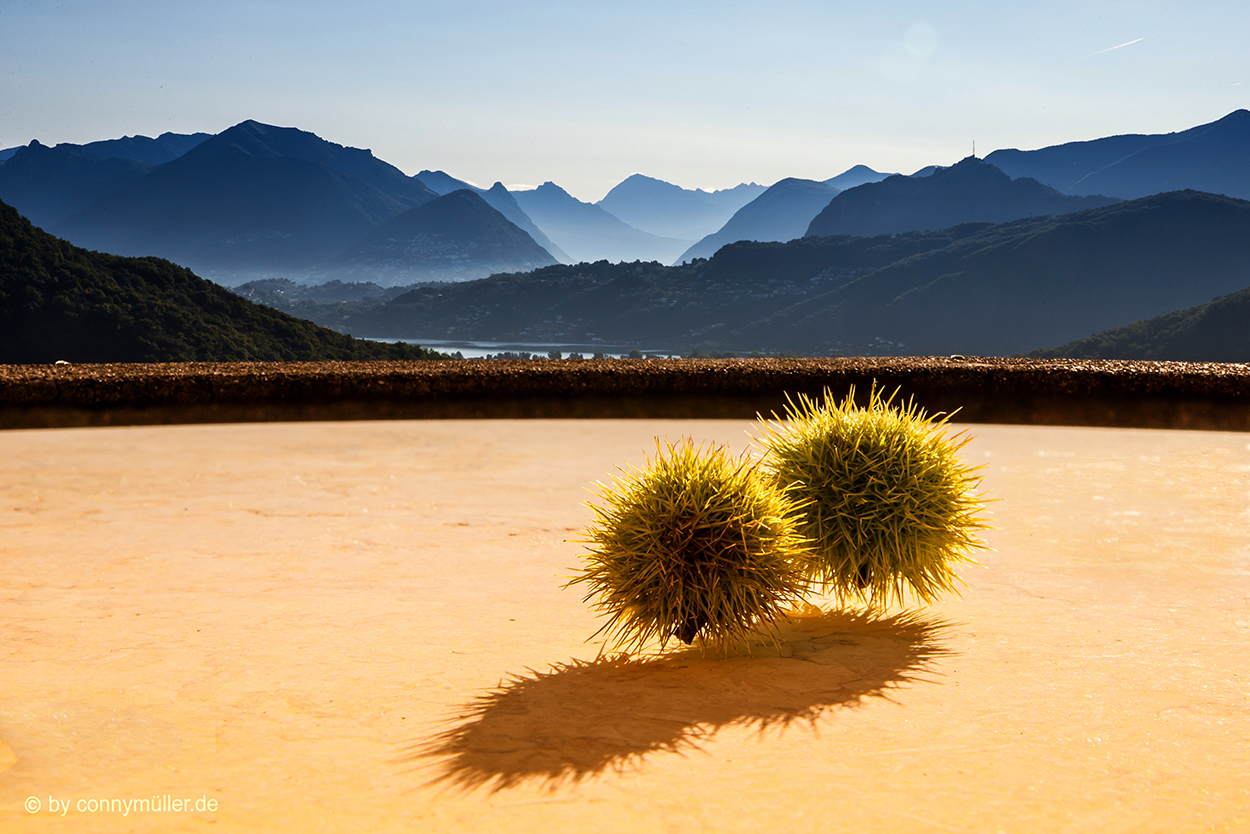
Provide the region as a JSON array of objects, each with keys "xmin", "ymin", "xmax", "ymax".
[{"xmin": 759, "ymin": 386, "xmax": 986, "ymax": 606}]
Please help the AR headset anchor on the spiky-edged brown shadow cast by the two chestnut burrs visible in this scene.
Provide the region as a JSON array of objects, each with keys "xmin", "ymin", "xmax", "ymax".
[{"xmin": 399, "ymin": 611, "xmax": 949, "ymax": 791}]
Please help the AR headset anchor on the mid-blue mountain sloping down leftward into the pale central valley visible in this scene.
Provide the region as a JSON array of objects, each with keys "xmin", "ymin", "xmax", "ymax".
[{"xmin": 679, "ymin": 178, "xmax": 839, "ymax": 263}]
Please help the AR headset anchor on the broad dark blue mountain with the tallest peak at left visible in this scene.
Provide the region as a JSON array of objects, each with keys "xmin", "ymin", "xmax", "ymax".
[{"xmin": 55, "ymin": 121, "xmax": 435, "ymax": 271}]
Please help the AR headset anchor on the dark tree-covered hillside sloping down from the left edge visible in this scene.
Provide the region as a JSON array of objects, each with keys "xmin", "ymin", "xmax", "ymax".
[{"xmin": 0, "ymin": 203, "xmax": 431, "ymax": 364}]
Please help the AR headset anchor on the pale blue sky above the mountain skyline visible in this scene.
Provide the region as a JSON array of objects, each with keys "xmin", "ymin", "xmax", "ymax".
[{"xmin": 0, "ymin": 0, "xmax": 1250, "ymax": 200}]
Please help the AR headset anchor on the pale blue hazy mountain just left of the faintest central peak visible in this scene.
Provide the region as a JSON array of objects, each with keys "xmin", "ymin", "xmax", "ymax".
[{"xmin": 513, "ymin": 183, "xmax": 689, "ymax": 261}]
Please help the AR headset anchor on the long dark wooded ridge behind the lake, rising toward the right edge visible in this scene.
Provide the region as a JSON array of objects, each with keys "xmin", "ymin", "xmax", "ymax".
[{"xmin": 292, "ymin": 191, "xmax": 1250, "ymax": 355}]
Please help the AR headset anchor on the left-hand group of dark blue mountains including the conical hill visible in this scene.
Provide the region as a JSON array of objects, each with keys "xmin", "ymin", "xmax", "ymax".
[{"xmin": 0, "ymin": 121, "xmax": 570, "ymax": 284}]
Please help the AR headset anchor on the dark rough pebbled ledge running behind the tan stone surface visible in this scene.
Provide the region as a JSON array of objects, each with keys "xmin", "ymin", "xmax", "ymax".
[{"xmin": 0, "ymin": 358, "xmax": 1250, "ymax": 431}]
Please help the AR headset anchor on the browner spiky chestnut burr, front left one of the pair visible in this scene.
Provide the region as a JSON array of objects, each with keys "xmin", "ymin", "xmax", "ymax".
[{"xmin": 570, "ymin": 439, "xmax": 808, "ymax": 651}]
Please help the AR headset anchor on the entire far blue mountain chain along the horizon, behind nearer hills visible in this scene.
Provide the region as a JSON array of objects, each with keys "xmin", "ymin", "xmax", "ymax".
[{"xmin": 9, "ymin": 110, "xmax": 1250, "ymax": 290}]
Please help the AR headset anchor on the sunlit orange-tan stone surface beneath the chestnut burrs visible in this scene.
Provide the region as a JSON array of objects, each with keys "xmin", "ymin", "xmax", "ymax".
[{"xmin": 0, "ymin": 420, "xmax": 1250, "ymax": 834}]
